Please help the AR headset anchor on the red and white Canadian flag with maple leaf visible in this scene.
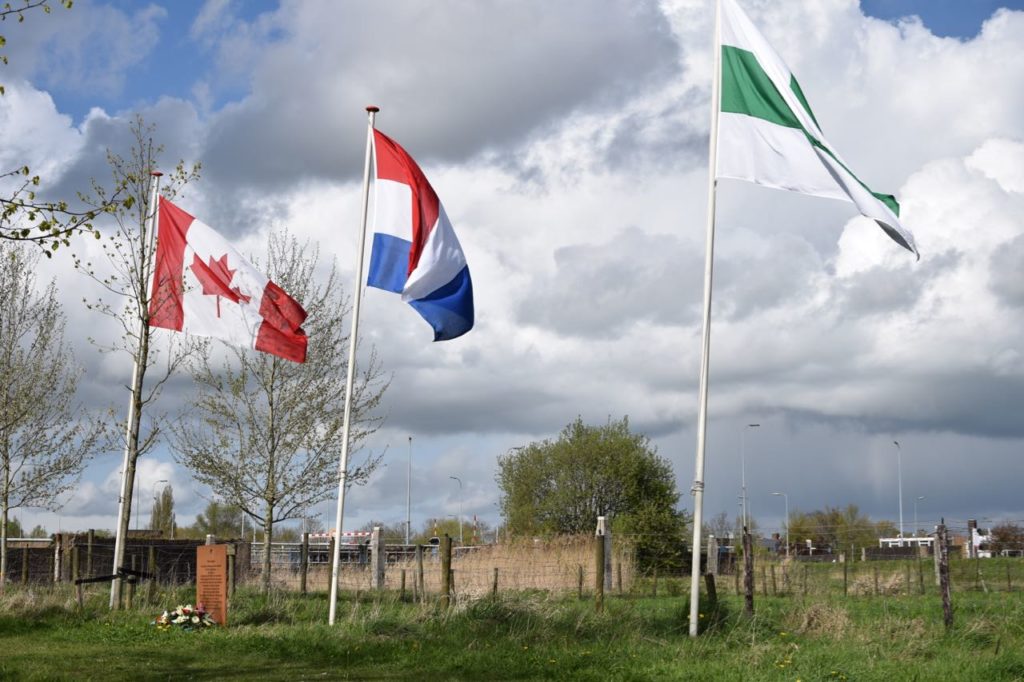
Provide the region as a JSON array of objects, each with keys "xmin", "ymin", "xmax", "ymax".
[{"xmin": 150, "ymin": 197, "xmax": 307, "ymax": 363}]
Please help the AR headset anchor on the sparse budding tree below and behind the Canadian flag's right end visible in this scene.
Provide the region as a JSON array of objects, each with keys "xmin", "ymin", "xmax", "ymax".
[{"xmin": 173, "ymin": 236, "xmax": 388, "ymax": 591}]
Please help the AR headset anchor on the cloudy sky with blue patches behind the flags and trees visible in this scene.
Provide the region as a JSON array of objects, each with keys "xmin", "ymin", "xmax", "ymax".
[{"xmin": 0, "ymin": 0, "xmax": 1024, "ymax": 532}]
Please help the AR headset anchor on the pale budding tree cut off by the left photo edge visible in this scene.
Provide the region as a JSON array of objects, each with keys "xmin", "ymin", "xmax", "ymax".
[{"xmin": 0, "ymin": 242, "xmax": 103, "ymax": 590}]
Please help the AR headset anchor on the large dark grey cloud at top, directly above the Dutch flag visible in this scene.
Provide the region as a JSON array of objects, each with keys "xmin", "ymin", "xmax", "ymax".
[{"xmin": 204, "ymin": 0, "xmax": 677, "ymax": 191}]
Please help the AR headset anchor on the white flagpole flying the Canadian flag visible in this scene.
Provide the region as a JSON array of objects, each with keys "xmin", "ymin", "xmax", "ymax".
[{"xmin": 110, "ymin": 171, "xmax": 163, "ymax": 608}]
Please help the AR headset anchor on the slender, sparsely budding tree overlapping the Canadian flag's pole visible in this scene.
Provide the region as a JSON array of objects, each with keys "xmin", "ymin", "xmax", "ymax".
[{"xmin": 75, "ymin": 117, "xmax": 200, "ymax": 608}]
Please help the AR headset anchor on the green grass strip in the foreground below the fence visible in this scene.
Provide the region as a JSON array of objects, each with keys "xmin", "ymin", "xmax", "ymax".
[{"xmin": 0, "ymin": 583, "xmax": 1024, "ymax": 680}]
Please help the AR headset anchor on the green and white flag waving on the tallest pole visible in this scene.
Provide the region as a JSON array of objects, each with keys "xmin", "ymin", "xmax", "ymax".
[{"xmin": 715, "ymin": 0, "xmax": 921, "ymax": 258}]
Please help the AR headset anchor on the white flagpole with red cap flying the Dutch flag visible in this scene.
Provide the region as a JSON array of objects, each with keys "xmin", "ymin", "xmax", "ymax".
[{"xmin": 328, "ymin": 105, "xmax": 380, "ymax": 625}]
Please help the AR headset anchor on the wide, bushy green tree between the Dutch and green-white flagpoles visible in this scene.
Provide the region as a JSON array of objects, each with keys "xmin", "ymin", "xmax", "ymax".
[{"xmin": 497, "ymin": 417, "xmax": 686, "ymax": 566}]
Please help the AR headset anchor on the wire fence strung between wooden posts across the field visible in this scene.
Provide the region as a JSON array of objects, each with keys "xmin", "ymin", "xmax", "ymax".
[{"xmin": 6, "ymin": 524, "xmax": 1024, "ymax": 598}]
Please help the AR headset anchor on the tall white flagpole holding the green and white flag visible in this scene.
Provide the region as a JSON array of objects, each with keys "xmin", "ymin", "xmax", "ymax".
[{"xmin": 690, "ymin": 0, "xmax": 722, "ymax": 637}]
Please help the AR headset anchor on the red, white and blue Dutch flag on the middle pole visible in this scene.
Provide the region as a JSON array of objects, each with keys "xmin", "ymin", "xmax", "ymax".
[{"xmin": 367, "ymin": 129, "xmax": 473, "ymax": 341}]
